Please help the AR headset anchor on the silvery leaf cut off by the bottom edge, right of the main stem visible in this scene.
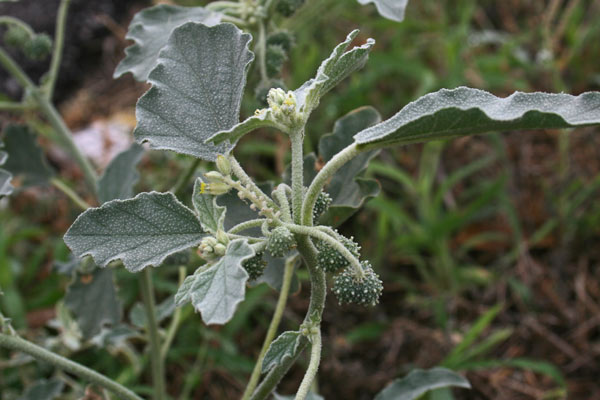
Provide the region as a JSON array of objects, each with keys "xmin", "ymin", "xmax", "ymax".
[{"xmin": 375, "ymin": 367, "xmax": 471, "ymax": 400}]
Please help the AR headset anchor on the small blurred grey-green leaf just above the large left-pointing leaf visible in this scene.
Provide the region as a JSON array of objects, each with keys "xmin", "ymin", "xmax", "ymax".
[{"xmin": 98, "ymin": 143, "xmax": 144, "ymax": 203}]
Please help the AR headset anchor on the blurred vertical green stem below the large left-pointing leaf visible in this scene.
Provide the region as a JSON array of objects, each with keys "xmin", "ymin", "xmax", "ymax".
[{"xmin": 139, "ymin": 268, "xmax": 166, "ymax": 400}]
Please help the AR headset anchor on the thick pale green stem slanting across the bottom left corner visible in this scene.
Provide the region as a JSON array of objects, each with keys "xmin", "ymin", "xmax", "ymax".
[{"xmin": 0, "ymin": 333, "xmax": 143, "ymax": 400}]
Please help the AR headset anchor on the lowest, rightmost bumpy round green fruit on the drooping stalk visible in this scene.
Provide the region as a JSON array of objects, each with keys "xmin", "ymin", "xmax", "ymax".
[{"xmin": 333, "ymin": 261, "xmax": 383, "ymax": 306}]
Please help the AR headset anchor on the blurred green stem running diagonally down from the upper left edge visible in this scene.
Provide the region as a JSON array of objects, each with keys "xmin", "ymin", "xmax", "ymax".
[{"xmin": 0, "ymin": 48, "xmax": 98, "ymax": 195}]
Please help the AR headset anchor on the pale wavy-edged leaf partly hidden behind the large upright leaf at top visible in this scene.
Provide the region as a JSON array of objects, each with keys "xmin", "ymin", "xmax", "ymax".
[{"xmin": 114, "ymin": 4, "xmax": 221, "ymax": 82}]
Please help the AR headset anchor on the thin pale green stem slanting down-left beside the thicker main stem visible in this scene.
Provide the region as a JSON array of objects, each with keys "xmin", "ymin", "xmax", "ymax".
[{"xmin": 242, "ymin": 257, "xmax": 296, "ymax": 400}]
